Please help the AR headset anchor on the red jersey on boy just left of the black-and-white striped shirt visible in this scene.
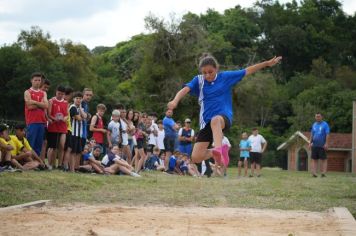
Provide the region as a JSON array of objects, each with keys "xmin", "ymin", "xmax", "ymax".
[{"xmin": 48, "ymin": 97, "xmax": 68, "ymax": 134}]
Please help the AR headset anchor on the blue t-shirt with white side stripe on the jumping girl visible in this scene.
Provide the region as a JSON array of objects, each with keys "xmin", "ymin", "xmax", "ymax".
[{"xmin": 185, "ymin": 69, "xmax": 246, "ymax": 129}]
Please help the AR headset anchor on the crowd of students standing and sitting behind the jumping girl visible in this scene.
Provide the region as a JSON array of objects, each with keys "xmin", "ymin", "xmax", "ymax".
[{"xmin": 0, "ymin": 73, "xmax": 266, "ymax": 177}]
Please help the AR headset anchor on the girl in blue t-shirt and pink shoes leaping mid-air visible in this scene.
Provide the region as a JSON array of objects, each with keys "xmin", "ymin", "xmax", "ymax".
[{"xmin": 167, "ymin": 55, "xmax": 282, "ymax": 167}]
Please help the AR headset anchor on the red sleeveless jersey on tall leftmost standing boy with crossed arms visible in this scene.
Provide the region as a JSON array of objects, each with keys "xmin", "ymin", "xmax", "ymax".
[{"xmin": 25, "ymin": 88, "xmax": 47, "ymax": 125}]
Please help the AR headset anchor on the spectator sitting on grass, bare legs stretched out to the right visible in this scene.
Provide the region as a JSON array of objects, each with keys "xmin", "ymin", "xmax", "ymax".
[{"xmin": 101, "ymin": 145, "xmax": 141, "ymax": 177}]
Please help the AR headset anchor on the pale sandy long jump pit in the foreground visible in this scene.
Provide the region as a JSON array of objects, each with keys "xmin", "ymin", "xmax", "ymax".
[{"xmin": 0, "ymin": 204, "xmax": 356, "ymax": 236}]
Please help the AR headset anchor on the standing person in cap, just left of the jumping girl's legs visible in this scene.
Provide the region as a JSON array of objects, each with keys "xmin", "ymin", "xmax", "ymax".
[{"xmin": 178, "ymin": 118, "xmax": 194, "ymax": 157}]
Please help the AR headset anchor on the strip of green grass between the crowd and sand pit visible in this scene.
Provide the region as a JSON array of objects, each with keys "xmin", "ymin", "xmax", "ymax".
[{"xmin": 0, "ymin": 168, "xmax": 356, "ymax": 217}]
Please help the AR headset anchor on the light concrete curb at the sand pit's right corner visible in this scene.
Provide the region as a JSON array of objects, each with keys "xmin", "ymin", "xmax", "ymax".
[{"xmin": 329, "ymin": 207, "xmax": 356, "ymax": 236}]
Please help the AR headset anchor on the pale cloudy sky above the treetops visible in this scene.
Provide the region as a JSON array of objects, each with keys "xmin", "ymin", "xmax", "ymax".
[{"xmin": 0, "ymin": 0, "xmax": 356, "ymax": 49}]
